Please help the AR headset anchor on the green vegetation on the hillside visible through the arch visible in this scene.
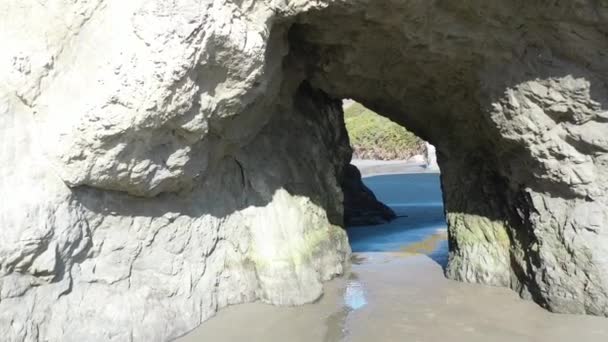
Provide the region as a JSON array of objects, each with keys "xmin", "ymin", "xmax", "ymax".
[{"xmin": 344, "ymin": 102, "xmax": 425, "ymax": 160}]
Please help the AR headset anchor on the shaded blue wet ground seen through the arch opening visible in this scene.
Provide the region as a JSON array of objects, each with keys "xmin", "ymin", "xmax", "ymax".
[{"xmin": 348, "ymin": 174, "xmax": 448, "ymax": 267}]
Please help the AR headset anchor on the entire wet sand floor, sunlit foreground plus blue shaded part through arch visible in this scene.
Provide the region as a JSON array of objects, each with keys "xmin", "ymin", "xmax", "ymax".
[{"xmin": 178, "ymin": 174, "xmax": 608, "ymax": 342}]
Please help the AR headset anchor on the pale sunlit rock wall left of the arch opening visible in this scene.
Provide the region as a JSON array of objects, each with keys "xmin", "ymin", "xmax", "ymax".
[{"xmin": 0, "ymin": 1, "xmax": 351, "ymax": 341}]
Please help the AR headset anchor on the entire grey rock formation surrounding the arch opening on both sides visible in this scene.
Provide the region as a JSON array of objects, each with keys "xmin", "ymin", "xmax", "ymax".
[{"xmin": 0, "ymin": 0, "xmax": 608, "ymax": 341}]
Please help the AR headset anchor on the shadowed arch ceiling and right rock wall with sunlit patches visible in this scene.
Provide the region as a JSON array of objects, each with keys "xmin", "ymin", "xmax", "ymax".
[{"xmin": 290, "ymin": 0, "xmax": 608, "ymax": 315}]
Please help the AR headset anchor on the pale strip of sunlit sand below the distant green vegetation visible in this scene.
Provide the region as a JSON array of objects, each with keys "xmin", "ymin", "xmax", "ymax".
[{"xmin": 351, "ymin": 159, "xmax": 439, "ymax": 178}]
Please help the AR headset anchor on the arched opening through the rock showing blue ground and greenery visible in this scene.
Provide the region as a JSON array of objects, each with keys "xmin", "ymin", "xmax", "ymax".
[{"xmin": 342, "ymin": 100, "xmax": 448, "ymax": 268}]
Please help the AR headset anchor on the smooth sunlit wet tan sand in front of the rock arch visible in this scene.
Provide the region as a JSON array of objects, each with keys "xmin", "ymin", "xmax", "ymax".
[{"xmin": 179, "ymin": 252, "xmax": 608, "ymax": 342}]
